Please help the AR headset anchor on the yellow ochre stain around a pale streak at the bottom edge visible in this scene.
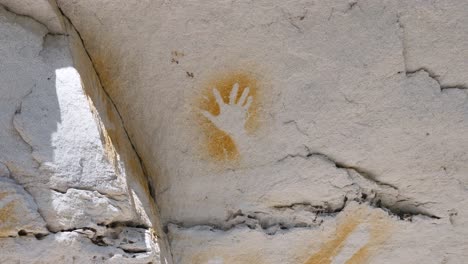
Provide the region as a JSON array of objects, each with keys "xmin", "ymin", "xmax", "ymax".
[{"xmin": 304, "ymin": 210, "xmax": 390, "ymax": 264}]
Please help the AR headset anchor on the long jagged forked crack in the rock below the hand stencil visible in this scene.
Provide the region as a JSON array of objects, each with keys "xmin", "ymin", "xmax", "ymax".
[{"xmin": 169, "ymin": 148, "xmax": 441, "ymax": 235}]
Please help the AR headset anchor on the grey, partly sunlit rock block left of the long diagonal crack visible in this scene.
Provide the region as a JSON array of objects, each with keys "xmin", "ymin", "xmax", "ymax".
[{"xmin": 0, "ymin": 2, "xmax": 167, "ymax": 263}]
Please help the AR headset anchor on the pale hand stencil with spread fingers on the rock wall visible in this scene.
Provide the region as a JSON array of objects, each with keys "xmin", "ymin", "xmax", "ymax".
[{"xmin": 202, "ymin": 83, "xmax": 253, "ymax": 139}]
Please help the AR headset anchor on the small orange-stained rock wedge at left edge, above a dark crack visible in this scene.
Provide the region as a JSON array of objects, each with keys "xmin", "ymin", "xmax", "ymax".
[{"xmin": 0, "ymin": 177, "xmax": 49, "ymax": 237}]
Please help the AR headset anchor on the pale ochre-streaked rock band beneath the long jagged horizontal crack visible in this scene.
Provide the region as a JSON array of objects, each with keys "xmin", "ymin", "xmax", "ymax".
[{"xmin": 169, "ymin": 203, "xmax": 467, "ymax": 264}]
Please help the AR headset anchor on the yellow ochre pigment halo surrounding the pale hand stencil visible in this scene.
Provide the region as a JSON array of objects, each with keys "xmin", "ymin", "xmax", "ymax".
[{"xmin": 196, "ymin": 71, "xmax": 260, "ymax": 161}]
